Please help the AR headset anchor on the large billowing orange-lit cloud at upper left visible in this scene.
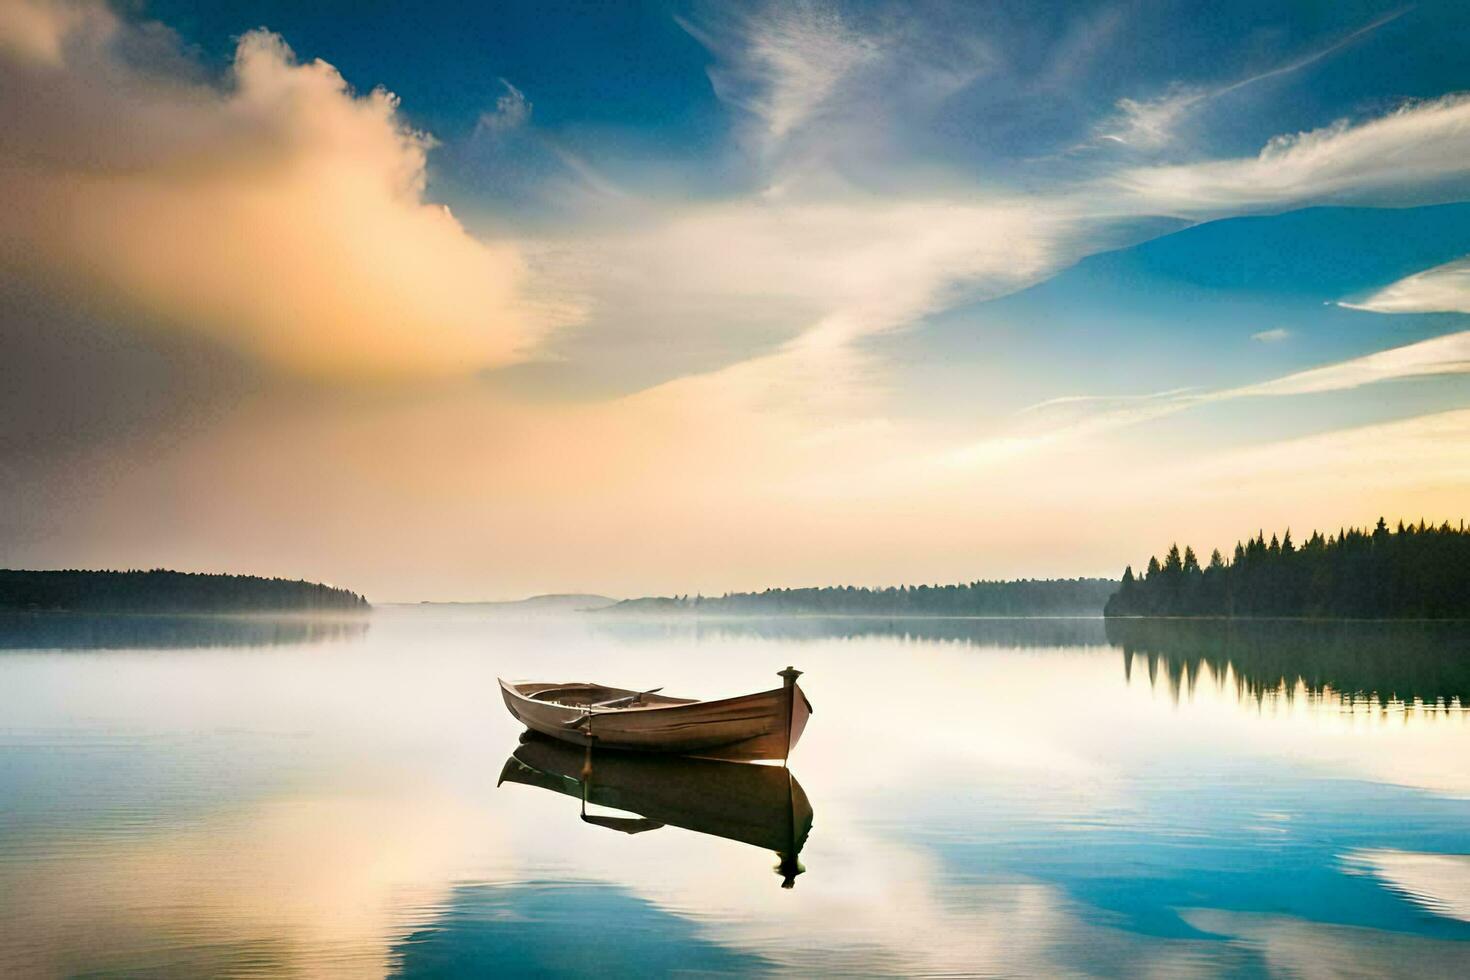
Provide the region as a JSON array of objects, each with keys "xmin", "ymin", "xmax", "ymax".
[{"xmin": 0, "ymin": 0, "xmax": 554, "ymax": 378}]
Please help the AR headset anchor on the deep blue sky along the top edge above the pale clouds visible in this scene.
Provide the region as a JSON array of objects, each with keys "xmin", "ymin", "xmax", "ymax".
[{"xmin": 137, "ymin": 0, "xmax": 1470, "ymax": 172}]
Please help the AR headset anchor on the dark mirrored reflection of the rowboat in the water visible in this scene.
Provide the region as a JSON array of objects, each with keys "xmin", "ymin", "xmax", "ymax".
[{"xmin": 500, "ymin": 735, "xmax": 811, "ymax": 887}]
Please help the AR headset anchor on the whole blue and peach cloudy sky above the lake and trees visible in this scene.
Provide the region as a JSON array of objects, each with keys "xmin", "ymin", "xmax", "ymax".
[{"xmin": 0, "ymin": 0, "xmax": 1470, "ymax": 601}]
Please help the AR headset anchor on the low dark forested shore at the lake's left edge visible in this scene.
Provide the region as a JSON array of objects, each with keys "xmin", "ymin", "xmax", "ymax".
[{"xmin": 0, "ymin": 569, "xmax": 368, "ymax": 613}]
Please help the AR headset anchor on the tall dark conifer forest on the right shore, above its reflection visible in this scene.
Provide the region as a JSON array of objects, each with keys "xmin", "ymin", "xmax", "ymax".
[{"xmin": 1105, "ymin": 517, "xmax": 1470, "ymax": 619}]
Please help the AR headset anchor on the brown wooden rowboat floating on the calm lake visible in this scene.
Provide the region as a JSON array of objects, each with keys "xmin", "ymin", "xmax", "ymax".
[{"xmin": 500, "ymin": 667, "xmax": 811, "ymax": 761}]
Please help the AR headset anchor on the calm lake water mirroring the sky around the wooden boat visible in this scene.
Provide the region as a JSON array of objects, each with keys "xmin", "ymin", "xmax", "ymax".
[{"xmin": 0, "ymin": 607, "xmax": 1470, "ymax": 977}]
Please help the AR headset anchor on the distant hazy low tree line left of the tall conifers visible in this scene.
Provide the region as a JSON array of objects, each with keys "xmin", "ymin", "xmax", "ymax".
[{"xmin": 609, "ymin": 579, "xmax": 1117, "ymax": 616}]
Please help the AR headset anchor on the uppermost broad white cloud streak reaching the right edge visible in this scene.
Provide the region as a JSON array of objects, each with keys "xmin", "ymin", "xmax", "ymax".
[{"xmin": 1104, "ymin": 93, "xmax": 1470, "ymax": 216}]
